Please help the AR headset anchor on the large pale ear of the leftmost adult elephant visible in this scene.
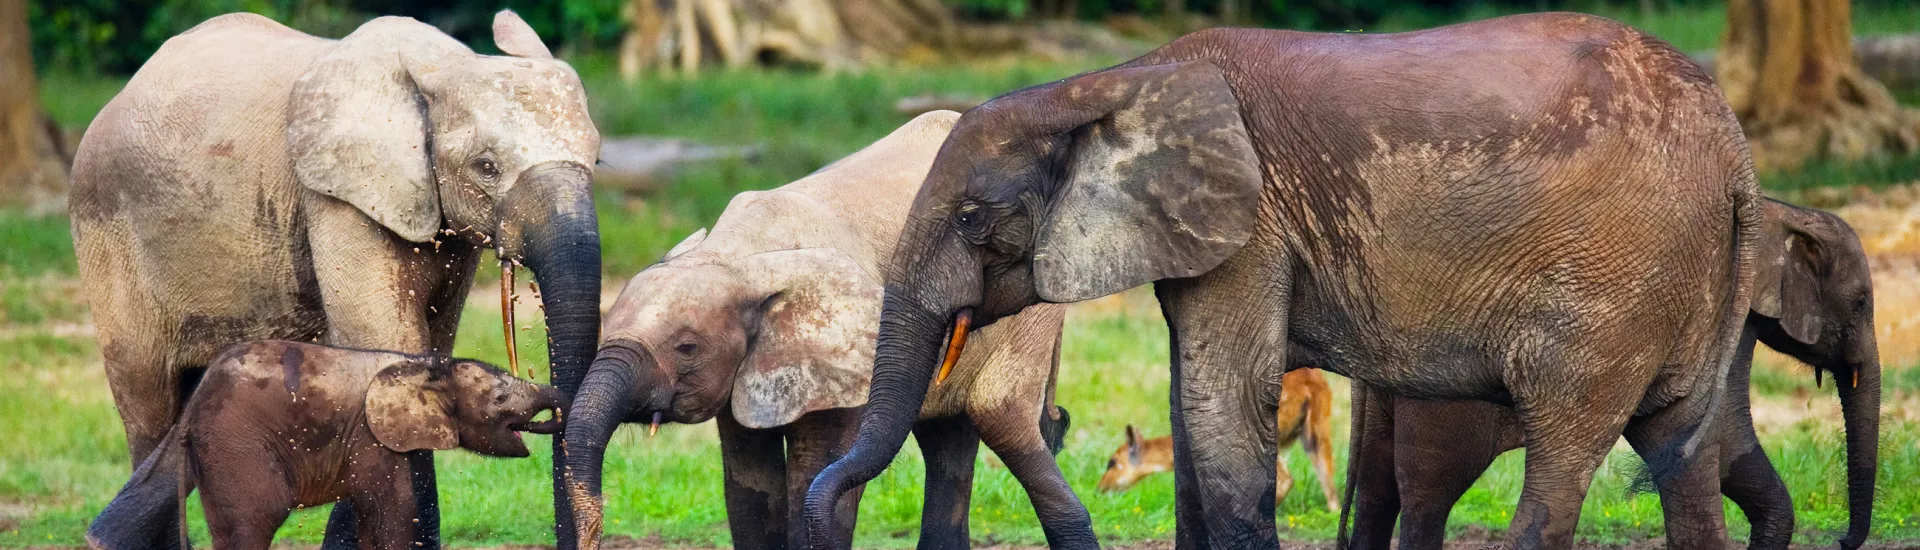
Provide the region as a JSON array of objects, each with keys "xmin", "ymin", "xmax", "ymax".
[{"xmin": 286, "ymin": 17, "xmax": 440, "ymax": 242}]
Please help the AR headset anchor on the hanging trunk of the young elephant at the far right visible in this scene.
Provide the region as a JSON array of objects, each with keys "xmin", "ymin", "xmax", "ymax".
[{"xmin": 1834, "ymin": 330, "xmax": 1880, "ymax": 550}]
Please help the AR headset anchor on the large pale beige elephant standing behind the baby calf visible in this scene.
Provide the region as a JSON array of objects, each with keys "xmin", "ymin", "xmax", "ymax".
[{"xmin": 71, "ymin": 12, "xmax": 599, "ymax": 548}]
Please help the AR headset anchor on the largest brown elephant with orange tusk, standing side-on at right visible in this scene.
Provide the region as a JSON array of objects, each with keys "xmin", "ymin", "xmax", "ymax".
[{"xmin": 804, "ymin": 13, "xmax": 1761, "ymax": 548}]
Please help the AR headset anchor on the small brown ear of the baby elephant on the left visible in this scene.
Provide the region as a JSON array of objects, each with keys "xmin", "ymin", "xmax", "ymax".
[{"xmin": 367, "ymin": 360, "xmax": 459, "ymax": 452}]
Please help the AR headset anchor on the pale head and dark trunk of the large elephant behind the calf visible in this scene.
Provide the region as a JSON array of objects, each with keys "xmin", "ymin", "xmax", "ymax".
[{"xmin": 286, "ymin": 12, "xmax": 601, "ymax": 398}]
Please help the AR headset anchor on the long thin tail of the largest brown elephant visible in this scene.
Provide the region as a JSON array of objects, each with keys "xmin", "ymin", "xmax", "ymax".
[{"xmin": 1674, "ymin": 164, "xmax": 1766, "ymax": 475}]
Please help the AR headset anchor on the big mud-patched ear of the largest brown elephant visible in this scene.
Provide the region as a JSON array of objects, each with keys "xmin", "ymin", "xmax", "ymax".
[{"xmin": 1033, "ymin": 62, "xmax": 1261, "ymax": 302}]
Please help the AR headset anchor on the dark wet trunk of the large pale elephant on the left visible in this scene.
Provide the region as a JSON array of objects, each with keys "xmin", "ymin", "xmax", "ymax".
[{"xmin": 495, "ymin": 162, "xmax": 601, "ymax": 550}]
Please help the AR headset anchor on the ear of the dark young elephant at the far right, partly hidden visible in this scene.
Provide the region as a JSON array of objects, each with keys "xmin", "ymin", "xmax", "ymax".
[{"xmin": 1753, "ymin": 231, "xmax": 1828, "ymax": 346}]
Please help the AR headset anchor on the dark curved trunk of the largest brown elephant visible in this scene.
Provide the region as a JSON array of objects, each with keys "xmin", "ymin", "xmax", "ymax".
[{"xmin": 806, "ymin": 290, "xmax": 948, "ymax": 548}]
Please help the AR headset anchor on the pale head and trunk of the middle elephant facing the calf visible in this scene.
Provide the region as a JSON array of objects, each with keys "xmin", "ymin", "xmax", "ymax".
[{"xmin": 566, "ymin": 233, "xmax": 879, "ymax": 548}]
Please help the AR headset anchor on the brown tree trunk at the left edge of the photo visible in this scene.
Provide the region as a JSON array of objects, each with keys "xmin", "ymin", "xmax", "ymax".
[{"xmin": 0, "ymin": 0, "xmax": 69, "ymax": 212}]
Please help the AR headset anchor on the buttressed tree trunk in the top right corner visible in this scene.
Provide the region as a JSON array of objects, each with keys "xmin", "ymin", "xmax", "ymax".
[{"xmin": 1715, "ymin": 0, "xmax": 1920, "ymax": 167}]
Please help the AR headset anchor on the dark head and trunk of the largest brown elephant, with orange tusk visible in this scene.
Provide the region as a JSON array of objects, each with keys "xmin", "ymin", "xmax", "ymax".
[{"xmin": 806, "ymin": 62, "xmax": 1261, "ymax": 537}]
